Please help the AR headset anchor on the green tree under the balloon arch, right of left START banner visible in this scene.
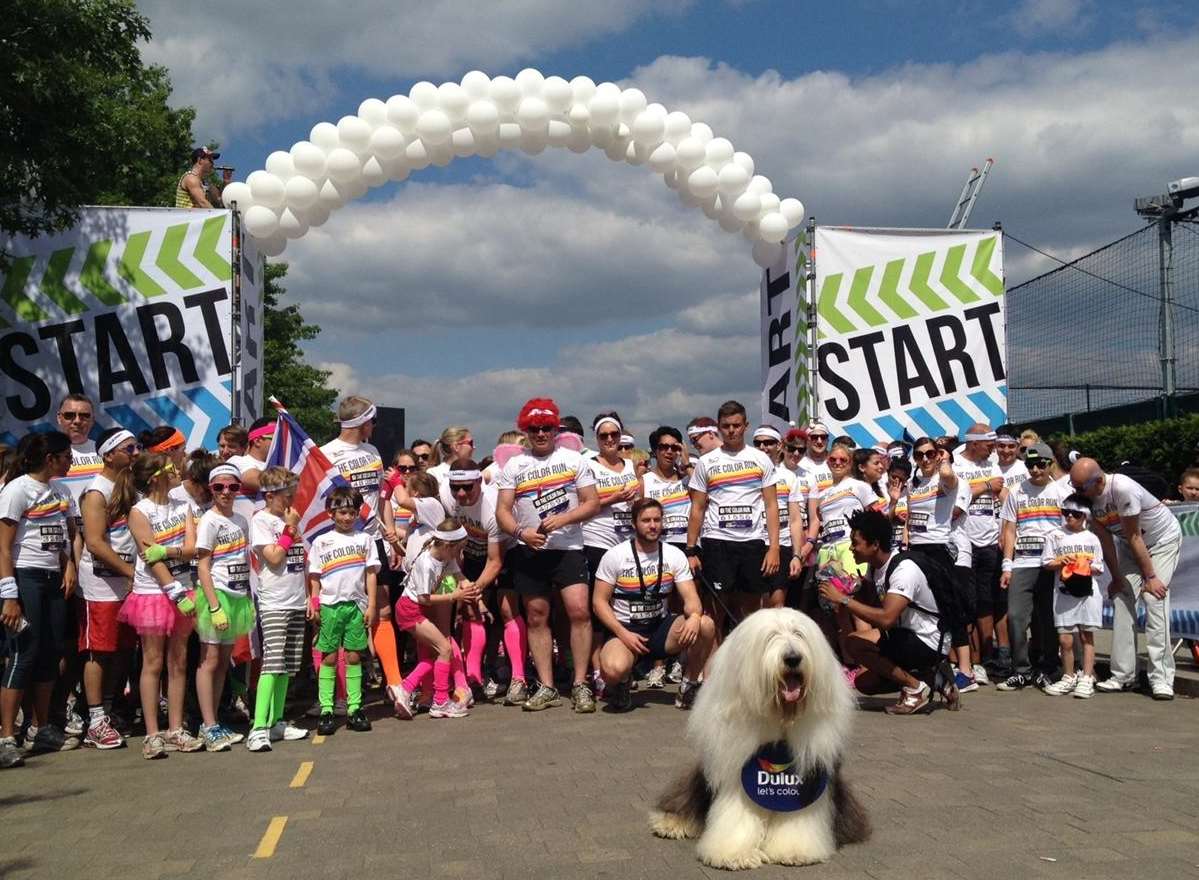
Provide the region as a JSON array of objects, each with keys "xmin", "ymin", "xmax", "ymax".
[{"xmin": 263, "ymin": 263, "xmax": 338, "ymax": 444}]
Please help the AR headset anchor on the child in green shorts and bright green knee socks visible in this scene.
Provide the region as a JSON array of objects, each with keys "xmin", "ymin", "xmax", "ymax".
[{"xmin": 308, "ymin": 486, "xmax": 381, "ymax": 736}]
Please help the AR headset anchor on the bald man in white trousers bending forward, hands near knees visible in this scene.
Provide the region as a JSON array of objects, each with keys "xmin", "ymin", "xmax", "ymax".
[{"xmin": 1070, "ymin": 458, "xmax": 1182, "ymax": 700}]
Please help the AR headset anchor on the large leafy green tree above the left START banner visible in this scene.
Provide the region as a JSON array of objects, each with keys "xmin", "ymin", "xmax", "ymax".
[{"xmin": 0, "ymin": 0, "xmax": 195, "ymax": 244}]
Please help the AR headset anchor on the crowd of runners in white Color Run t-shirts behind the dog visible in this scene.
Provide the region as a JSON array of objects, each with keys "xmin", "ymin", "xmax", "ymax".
[{"xmin": 0, "ymin": 394, "xmax": 1199, "ymax": 767}]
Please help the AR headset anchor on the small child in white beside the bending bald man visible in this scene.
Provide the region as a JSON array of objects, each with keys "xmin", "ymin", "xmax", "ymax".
[{"xmin": 1041, "ymin": 493, "xmax": 1103, "ymax": 700}]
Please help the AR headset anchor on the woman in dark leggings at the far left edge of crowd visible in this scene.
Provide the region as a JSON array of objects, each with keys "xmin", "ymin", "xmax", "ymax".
[{"xmin": 0, "ymin": 430, "xmax": 79, "ymax": 767}]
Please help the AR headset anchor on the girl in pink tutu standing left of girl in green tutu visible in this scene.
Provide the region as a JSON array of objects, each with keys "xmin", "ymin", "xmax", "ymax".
[{"xmin": 118, "ymin": 452, "xmax": 204, "ymax": 759}]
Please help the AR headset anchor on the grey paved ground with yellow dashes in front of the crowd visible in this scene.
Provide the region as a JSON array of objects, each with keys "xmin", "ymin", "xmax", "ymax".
[{"xmin": 0, "ymin": 666, "xmax": 1199, "ymax": 880}]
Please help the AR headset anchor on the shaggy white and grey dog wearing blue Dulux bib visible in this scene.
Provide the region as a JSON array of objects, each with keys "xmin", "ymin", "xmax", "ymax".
[{"xmin": 651, "ymin": 608, "xmax": 870, "ymax": 869}]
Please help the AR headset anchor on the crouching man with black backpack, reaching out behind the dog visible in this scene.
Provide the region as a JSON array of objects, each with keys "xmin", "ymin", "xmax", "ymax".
[{"xmin": 819, "ymin": 511, "xmax": 960, "ymax": 715}]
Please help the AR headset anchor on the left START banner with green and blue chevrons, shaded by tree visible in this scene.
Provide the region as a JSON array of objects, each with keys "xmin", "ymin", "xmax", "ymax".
[{"xmin": 0, "ymin": 207, "xmax": 263, "ymax": 448}]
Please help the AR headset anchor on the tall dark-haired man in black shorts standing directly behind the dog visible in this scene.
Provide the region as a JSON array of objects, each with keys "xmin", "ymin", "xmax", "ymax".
[{"xmin": 687, "ymin": 400, "xmax": 779, "ymax": 629}]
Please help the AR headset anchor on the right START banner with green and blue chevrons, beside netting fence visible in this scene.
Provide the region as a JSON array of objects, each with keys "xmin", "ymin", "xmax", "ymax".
[{"xmin": 813, "ymin": 227, "xmax": 1007, "ymax": 446}]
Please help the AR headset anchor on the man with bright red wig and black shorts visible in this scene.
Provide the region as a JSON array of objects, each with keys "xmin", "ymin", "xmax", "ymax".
[{"xmin": 495, "ymin": 398, "xmax": 600, "ymax": 712}]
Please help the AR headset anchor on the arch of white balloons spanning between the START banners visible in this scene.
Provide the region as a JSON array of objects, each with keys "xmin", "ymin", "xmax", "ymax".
[{"xmin": 224, "ymin": 68, "xmax": 803, "ymax": 266}]
